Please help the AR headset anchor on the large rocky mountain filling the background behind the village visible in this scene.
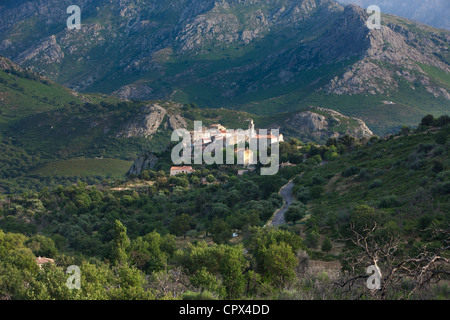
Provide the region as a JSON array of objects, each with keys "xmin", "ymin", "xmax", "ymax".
[{"xmin": 0, "ymin": 0, "xmax": 450, "ymax": 134}]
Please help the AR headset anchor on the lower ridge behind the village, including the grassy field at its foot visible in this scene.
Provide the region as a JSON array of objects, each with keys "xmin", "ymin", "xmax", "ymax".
[{"xmin": 0, "ymin": 57, "xmax": 371, "ymax": 193}]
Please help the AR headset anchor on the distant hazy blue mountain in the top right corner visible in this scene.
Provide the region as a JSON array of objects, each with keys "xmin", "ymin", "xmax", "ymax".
[{"xmin": 339, "ymin": 0, "xmax": 450, "ymax": 30}]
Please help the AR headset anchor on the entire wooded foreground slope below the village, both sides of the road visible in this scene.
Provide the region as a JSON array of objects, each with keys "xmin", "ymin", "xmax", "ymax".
[{"xmin": 0, "ymin": 116, "xmax": 450, "ymax": 303}]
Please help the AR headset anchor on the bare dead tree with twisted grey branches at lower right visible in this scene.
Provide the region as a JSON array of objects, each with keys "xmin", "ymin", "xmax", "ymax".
[{"xmin": 334, "ymin": 223, "xmax": 450, "ymax": 300}]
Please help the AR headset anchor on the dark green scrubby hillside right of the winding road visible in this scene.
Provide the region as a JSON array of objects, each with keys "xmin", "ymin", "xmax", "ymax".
[{"xmin": 293, "ymin": 117, "xmax": 450, "ymax": 249}]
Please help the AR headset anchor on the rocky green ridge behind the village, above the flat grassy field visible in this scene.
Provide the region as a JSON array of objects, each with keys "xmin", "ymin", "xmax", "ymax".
[{"xmin": 0, "ymin": 58, "xmax": 372, "ymax": 166}]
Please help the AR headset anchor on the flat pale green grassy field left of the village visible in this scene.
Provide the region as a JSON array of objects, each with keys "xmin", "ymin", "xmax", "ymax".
[{"xmin": 31, "ymin": 159, "xmax": 133, "ymax": 177}]
